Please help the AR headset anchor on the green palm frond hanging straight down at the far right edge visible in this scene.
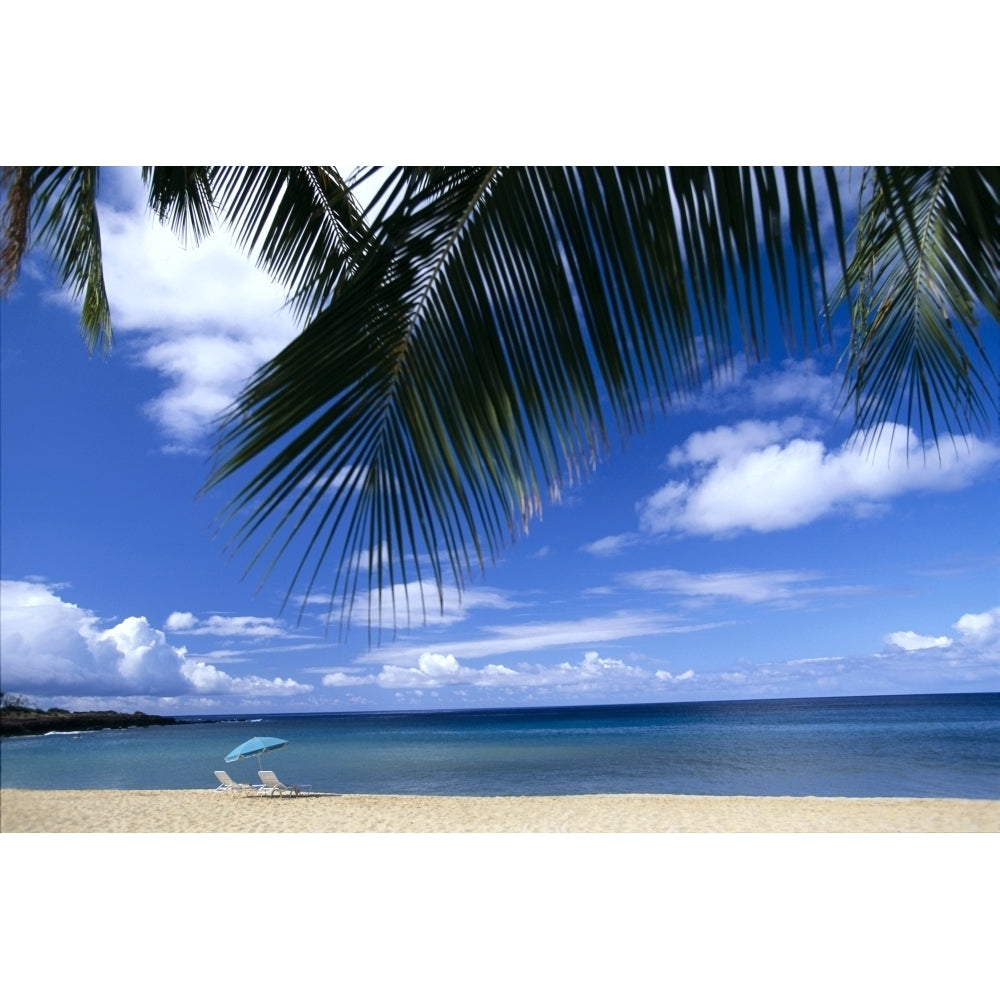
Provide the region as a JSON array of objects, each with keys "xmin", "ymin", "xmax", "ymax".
[{"xmin": 840, "ymin": 167, "xmax": 1000, "ymax": 440}]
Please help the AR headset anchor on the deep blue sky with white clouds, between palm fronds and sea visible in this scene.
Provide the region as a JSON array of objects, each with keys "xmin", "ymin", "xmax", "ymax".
[{"xmin": 0, "ymin": 170, "xmax": 1000, "ymax": 714}]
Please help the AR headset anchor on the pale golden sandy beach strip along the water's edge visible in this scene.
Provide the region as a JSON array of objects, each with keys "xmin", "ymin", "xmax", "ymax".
[{"xmin": 0, "ymin": 789, "xmax": 1000, "ymax": 833}]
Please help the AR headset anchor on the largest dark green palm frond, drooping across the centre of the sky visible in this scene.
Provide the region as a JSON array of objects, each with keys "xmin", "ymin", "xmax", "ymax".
[{"xmin": 208, "ymin": 168, "xmax": 833, "ymax": 624}]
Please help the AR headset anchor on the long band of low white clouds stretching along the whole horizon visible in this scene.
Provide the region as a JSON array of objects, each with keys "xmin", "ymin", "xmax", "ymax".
[{"xmin": 0, "ymin": 580, "xmax": 1000, "ymax": 711}]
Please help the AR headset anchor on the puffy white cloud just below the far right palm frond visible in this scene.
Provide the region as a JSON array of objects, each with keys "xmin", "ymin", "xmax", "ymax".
[{"xmin": 638, "ymin": 420, "xmax": 1000, "ymax": 537}]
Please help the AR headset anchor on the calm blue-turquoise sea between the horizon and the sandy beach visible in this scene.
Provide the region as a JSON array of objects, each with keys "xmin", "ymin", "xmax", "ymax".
[{"xmin": 0, "ymin": 693, "xmax": 1000, "ymax": 799}]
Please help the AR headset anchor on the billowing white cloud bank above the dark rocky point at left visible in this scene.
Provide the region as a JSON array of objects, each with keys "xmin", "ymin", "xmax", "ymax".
[{"xmin": 0, "ymin": 580, "xmax": 312, "ymax": 700}]
